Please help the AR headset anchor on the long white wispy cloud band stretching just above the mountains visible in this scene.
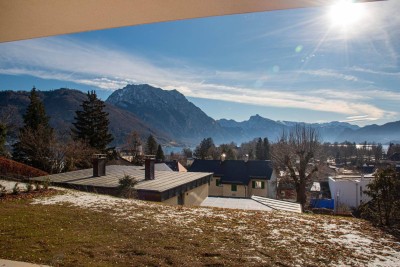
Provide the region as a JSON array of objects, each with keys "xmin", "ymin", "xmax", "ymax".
[{"xmin": 0, "ymin": 37, "xmax": 391, "ymax": 123}]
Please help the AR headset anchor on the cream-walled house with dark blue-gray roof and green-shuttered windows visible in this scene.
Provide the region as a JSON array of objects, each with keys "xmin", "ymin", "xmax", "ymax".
[{"xmin": 188, "ymin": 159, "xmax": 276, "ymax": 198}]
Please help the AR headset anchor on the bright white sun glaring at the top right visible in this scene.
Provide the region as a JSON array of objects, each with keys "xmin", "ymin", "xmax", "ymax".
[{"xmin": 329, "ymin": 0, "xmax": 366, "ymax": 30}]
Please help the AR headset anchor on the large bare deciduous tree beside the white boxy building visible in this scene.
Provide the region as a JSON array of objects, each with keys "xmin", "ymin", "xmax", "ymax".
[{"xmin": 272, "ymin": 124, "xmax": 320, "ymax": 206}]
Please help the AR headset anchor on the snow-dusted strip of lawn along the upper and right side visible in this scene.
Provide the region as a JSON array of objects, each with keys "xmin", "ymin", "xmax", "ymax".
[{"xmin": 0, "ymin": 181, "xmax": 400, "ymax": 266}]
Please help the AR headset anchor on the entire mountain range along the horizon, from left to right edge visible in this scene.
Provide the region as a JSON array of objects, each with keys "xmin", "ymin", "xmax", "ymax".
[{"xmin": 0, "ymin": 84, "xmax": 400, "ymax": 146}]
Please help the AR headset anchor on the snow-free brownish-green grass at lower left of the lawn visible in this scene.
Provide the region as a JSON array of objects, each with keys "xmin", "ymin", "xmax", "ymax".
[{"xmin": 0, "ymin": 200, "xmax": 247, "ymax": 266}]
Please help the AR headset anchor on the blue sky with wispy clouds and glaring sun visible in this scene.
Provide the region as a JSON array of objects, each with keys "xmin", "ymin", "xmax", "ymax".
[{"xmin": 0, "ymin": 0, "xmax": 400, "ymax": 126}]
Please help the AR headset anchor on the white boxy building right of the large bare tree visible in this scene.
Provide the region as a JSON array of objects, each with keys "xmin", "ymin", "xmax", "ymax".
[{"xmin": 329, "ymin": 174, "xmax": 375, "ymax": 213}]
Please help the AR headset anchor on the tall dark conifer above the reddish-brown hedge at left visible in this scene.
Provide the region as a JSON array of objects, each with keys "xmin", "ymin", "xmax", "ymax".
[{"xmin": 13, "ymin": 87, "xmax": 55, "ymax": 172}]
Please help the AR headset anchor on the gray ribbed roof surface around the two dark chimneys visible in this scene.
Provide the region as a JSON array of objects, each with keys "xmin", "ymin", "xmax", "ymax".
[{"xmin": 33, "ymin": 165, "xmax": 212, "ymax": 192}]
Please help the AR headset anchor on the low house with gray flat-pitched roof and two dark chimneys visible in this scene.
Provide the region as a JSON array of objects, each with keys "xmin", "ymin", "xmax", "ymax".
[{"xmin": 32, "ymin": 157, "xmax": 212, "ymax": 206}]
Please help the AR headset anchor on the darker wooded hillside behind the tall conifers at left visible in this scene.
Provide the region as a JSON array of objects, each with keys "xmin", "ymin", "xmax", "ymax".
[{"xmin": 0, "ymin": 89, "xmax": 171, "ymax": 145}]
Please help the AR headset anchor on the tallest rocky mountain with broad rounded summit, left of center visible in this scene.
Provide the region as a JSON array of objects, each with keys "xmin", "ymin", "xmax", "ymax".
[{"xmin": 106, "ymin": 84, "xmax": 233, "ymax": 144}]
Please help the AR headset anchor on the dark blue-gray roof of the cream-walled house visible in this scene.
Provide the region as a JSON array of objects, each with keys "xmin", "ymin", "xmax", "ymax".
[{"xmin": 188, "ymin": 159, "xmax": 273, "ymax": 184}]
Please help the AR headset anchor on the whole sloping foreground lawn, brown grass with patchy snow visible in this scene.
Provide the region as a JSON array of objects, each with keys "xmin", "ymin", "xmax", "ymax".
[{"xmin": 0, "ymin": 189, "xmax": 400, "ymax": 266}]
